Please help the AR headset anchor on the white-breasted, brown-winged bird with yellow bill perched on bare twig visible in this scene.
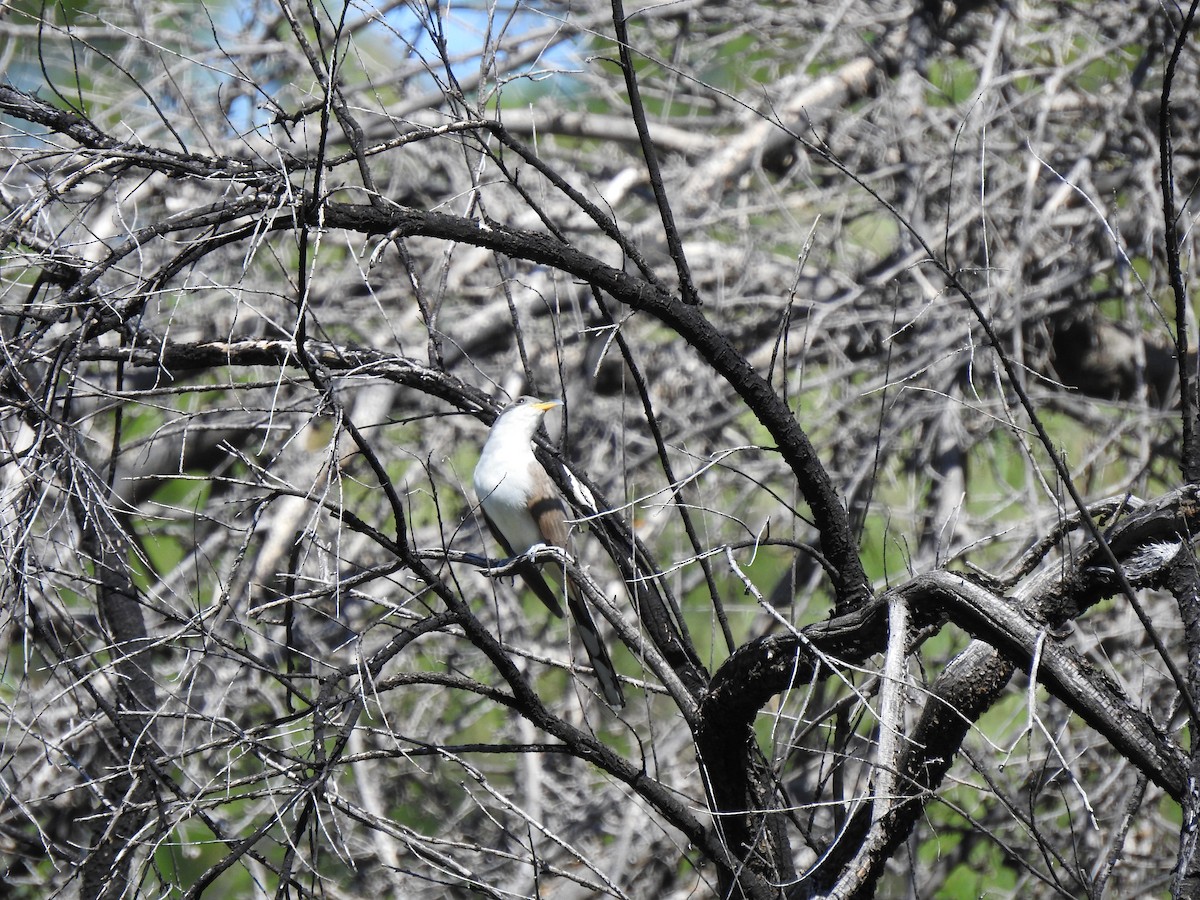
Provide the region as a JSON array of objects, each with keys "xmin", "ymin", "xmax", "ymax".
[{"xmin": 474, "ymin": 397, "xmax": 625, "ymax": 708}]
